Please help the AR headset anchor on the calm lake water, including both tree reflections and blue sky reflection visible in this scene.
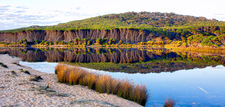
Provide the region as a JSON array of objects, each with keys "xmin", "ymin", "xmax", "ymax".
[{"xmin": 1, "ymin": 49, "xmax": 225, "ymax": 107}]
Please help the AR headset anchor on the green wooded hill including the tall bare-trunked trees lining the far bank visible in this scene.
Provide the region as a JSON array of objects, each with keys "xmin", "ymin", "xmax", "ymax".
[{"xmin": 0, "ymin": 12, "xmax": 225, "ymax": 46}]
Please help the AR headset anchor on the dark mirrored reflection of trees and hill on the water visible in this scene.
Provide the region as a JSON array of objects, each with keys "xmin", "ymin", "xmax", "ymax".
[{"xmin": 1, "ymin": 48, "xmax": 225, "ymax": 73}]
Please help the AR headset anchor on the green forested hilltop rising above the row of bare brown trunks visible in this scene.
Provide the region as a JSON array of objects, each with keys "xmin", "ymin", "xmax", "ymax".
[{"xmin": 1, "ymin": 12, "xmax": 225, "ymax": 32}]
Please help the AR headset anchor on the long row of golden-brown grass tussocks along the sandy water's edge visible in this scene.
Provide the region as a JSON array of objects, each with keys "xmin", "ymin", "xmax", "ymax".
[{"xmin": 55, "ymin": 64, "xmax": 148, "ymax": 105}]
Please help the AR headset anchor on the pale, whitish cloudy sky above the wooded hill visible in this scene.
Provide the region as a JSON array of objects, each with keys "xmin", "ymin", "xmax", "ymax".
[{"xmin": 0, "ymin": 0, "xmax": 225, "ymax": 30}]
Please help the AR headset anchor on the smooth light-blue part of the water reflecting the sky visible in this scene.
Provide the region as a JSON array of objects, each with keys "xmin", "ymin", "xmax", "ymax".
[{"xmin": 20, "ymin": 61, "xmax": 225, "ymax": 106}]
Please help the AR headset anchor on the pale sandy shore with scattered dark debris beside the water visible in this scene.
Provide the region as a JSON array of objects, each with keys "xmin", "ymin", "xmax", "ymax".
[{"xmin": 0, "ymin": 54, "xmax": 141, "ymax": 107}]
